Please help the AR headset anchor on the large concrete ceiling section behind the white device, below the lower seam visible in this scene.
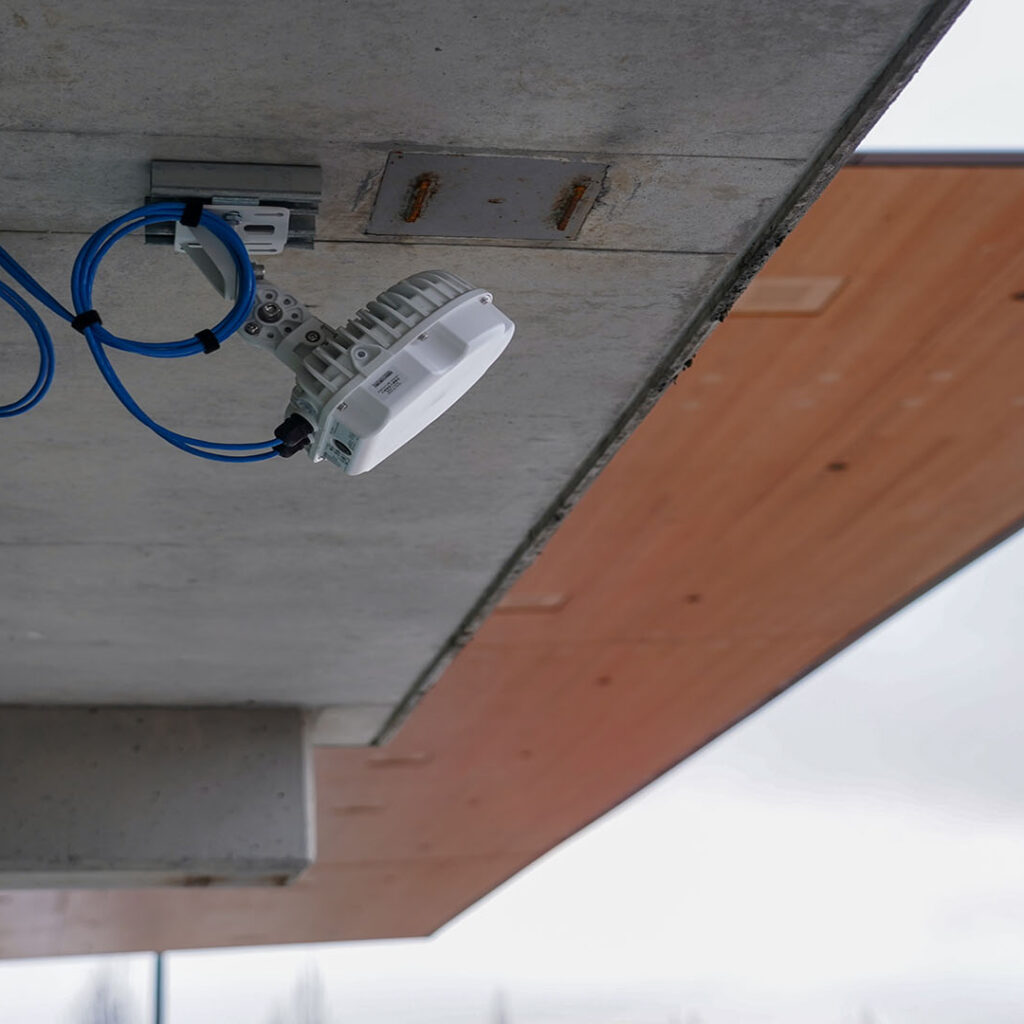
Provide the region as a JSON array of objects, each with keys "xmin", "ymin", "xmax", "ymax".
[{"xmin": 0, "ymin": 236, "xmax": 726, "ymax": 727}]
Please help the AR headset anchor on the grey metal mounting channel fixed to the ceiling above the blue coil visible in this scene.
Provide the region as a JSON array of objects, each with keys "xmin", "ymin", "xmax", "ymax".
[{"xmin": 145, "ymin": 160, "xmax": 323, "ymax": 249}]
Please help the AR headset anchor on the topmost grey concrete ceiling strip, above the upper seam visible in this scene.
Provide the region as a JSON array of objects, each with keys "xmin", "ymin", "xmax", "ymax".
[{"xmin": 3, "ymin": 0, "xmax": 933, "ymax": 159}]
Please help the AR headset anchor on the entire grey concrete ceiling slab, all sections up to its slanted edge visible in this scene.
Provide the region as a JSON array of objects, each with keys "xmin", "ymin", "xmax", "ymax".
[{"xmin": 0, "ymin": 0, "xmax": 963, "ymax": 741}]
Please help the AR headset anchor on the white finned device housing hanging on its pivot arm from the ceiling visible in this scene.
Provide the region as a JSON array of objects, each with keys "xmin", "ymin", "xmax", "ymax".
[{"xmin": 245, "ymin": 270, "xmax": 515, "ymax": 476}]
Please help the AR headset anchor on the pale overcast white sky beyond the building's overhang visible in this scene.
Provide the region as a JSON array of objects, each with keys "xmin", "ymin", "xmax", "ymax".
[{"xmin": 0, "ymin": 0, "xmax": 1024, "ymax": 1024}]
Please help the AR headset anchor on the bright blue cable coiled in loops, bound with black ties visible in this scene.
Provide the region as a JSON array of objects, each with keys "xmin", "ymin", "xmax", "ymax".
[{"xmin": 0, "ymin": 203, "xmax": 281, "ymax": 462}]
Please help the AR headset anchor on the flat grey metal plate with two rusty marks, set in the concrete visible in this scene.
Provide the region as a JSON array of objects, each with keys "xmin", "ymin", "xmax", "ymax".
[{"xmin": 367, "ymin": 150, "xmax": 608, "ymax": 241}]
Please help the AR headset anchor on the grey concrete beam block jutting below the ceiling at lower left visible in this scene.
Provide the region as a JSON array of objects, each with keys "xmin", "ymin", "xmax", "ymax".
[{"xmin": 0, "ymin": 707, "xmax": 313, "ymax": 889}]
